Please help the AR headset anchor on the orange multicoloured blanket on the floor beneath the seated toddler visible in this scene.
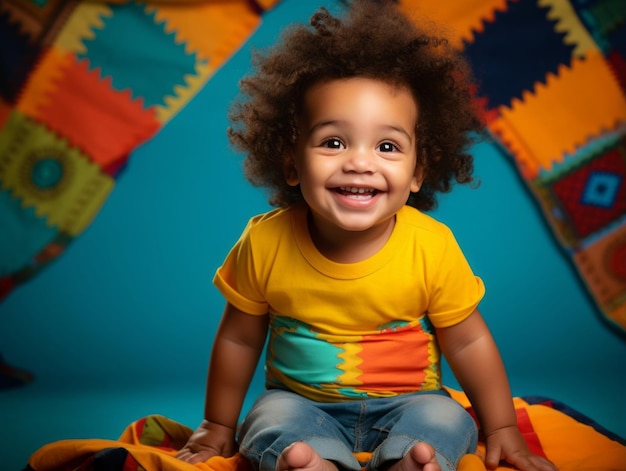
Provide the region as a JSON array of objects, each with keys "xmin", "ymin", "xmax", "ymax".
[{"xmin": 25, "ymin": 390, "xmax": 626, "ymax": 471}]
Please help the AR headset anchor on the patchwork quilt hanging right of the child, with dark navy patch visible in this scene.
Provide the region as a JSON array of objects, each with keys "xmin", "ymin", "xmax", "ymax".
[{"xmin": 400, "ymin": 0, "xmax": 626, "ymax": 333}]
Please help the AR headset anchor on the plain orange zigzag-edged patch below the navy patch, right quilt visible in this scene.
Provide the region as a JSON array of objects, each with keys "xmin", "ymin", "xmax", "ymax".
[{"xmin": 490, "ymin": 49, "xmax": 626, "ymax": 180}]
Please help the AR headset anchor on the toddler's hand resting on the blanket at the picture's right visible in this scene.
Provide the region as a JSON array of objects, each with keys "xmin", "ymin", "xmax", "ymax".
[{"xmin": 485, "ymin": 426, "xmax": 558, "ymax": 471}]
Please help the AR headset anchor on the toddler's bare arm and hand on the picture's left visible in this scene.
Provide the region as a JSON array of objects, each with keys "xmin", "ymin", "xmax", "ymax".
[{"xmin": 176, "ymin": 303, "xmax": 268, "ymax": 463}]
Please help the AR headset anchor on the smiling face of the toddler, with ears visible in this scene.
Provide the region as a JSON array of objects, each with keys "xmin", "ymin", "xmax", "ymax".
[{"xmin": 285, "ymin": 78, "xmax": 422, "ymax": 238}]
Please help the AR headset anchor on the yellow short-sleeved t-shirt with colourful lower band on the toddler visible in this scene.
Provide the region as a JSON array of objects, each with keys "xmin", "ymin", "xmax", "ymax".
[{"xmin": 214, "ymin": 205, "xmax": 485, "ymax": 402}]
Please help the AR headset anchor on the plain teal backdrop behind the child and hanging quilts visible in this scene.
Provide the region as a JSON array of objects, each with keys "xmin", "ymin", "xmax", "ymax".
[{"xmin": 0, "ymin": 0, "xmax": 626, "ymax": 471}]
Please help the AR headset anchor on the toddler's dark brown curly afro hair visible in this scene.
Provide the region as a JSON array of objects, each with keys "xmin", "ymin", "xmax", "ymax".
[{"xmin": 229, "ymin": 0, "xmax": 483, "ymax": 211}]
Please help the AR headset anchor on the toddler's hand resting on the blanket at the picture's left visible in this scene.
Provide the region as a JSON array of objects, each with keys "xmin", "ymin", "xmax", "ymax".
[{"xmin": 176, "ymin": 420, "xmax": 237, "ymax": 464}]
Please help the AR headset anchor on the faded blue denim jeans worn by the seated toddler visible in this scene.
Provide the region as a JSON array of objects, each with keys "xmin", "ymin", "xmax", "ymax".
[{"xmin": 238, "ymin": 389, "xmax": 478, "ymax": 471}]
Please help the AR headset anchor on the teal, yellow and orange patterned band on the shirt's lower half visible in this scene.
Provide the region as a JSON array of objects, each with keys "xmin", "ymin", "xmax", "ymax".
[{"xmin": 266, "ymin": 316, "xmax": 441, "ymax": 401}]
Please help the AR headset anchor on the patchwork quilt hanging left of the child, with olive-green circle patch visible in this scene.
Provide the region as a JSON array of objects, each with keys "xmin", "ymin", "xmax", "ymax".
[{"xmin": 0, "ymin": 0, "xmax": 279, "ymax": 299}]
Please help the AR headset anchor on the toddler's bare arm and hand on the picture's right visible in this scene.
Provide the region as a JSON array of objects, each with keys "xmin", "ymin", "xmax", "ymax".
[{"xmin": 437, "ymin": 311, "xmax": 556, "ymax": 471}]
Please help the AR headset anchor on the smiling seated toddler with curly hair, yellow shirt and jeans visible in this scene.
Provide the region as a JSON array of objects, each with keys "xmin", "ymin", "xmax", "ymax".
[{"xmin": 178, "ymin": 0, "xmax": 556, "ymax": 471}]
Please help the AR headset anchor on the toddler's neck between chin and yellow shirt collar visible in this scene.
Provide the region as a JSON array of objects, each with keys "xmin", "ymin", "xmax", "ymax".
[{"xmin": 308, "ymin": 212, "xmax": 396, "ymax": 263}]
